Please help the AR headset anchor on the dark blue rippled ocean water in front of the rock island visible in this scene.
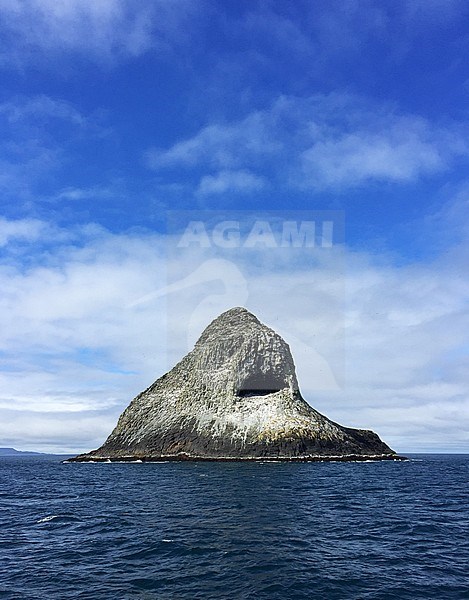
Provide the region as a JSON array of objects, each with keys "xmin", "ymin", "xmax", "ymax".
[{"xmin": 0, "ymin": 455, "xmax": 469, "ymax": 600}]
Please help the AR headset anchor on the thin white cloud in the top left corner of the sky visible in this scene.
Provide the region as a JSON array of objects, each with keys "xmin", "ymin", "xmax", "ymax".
[{"xmin": 0, "ymin": 0, "xmax": 196, "ymax": 66}]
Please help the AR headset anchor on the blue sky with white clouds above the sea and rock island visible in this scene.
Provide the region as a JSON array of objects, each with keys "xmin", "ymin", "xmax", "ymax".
[{"xmin": 0, "ymin": 0, "xmax": 469, "ymax": 451}]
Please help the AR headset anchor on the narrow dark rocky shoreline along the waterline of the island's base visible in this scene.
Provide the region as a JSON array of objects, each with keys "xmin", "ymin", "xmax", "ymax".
[{"xmin": 63, "ymin": 453, "xmax": 409, "ymax": 463}]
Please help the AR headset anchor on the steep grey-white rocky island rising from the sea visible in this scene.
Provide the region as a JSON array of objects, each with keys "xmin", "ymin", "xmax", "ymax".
[{"xmin": 72, "ymin": 308, "xmax": 400, "ymax": 461}]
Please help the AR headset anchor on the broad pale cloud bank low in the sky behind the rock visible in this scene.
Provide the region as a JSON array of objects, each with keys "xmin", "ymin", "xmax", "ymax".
[{"xmin": 0, "ymin": 207, "xmax": 469, "ymax": 451}]
